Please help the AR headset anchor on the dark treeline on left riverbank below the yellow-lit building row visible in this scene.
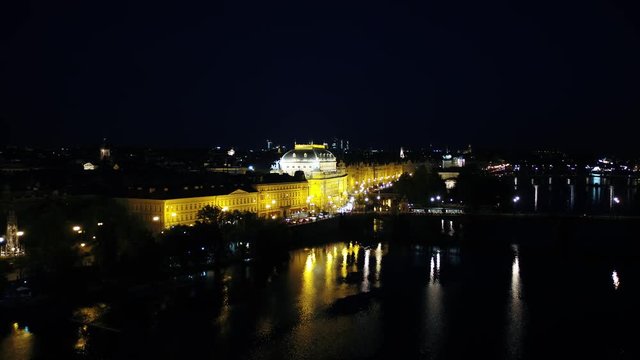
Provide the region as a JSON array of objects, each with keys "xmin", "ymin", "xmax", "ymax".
[{"xmin": 0, "ymin": 197, "xmax": 290, "ymax": 298}]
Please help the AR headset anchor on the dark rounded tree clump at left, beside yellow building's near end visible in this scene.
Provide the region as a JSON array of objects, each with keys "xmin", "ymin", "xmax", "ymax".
[{"xmin": 20, "ymin": 197, "xmax": 159, "ymax": 283}]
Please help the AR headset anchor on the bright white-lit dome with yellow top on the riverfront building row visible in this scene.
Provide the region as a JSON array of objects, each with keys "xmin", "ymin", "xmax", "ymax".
[{"xmin": 280, "ymin": 144, "xmax": 337, "ymax": 177}]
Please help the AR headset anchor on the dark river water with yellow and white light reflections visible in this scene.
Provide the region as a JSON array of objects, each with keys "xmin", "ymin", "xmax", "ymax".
[{"xmin": 0, "ymin": 221, "xmax": 640, "ymax": 360}]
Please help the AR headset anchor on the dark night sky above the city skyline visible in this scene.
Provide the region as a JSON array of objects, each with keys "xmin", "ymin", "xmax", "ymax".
[{"xmin": 0, "ymin": 0, "xmax": 640, "ymax": 149}]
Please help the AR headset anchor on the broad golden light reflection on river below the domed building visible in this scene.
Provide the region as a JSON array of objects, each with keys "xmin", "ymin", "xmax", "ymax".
[{"xmin": 276, "ymin": 243, "xmax": 384, "ymax": 359}]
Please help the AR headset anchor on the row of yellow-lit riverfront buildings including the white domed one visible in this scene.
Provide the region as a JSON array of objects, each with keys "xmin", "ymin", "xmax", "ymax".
[{"xmin": 119, "ymin": 144, "xmax": 415, "ymax": 231}]
